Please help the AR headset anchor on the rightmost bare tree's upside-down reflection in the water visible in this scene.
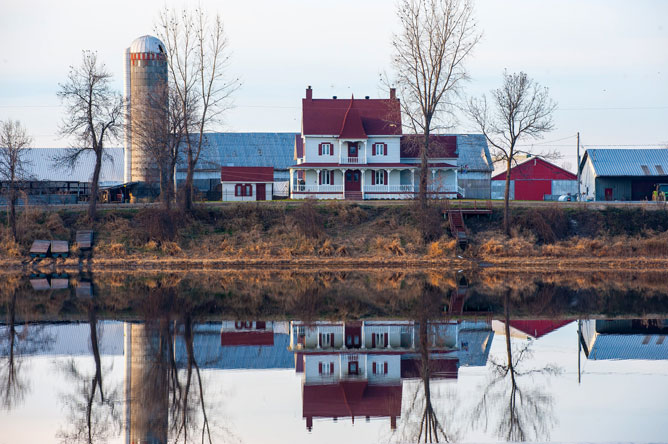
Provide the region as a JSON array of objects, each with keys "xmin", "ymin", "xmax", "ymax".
[{"xmin": 470, "ymin": 291, "xmax": 561, "ymax": 441}]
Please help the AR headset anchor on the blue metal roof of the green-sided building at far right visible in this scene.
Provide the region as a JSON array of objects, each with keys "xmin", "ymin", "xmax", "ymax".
[{"xmin": 580, "ymin": 148, "xmax": 668, "ymax": 176}]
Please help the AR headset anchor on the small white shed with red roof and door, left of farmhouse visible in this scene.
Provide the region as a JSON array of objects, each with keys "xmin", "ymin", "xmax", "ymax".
[{"xmin": 220, "ymin": 167, "xmax": 274, "ymax": 202}]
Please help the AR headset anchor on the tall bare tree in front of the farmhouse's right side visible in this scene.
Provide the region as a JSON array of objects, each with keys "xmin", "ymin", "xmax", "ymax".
[{"xmin": 392, "ymin": 0, "xmax": 481, "ymax": 209}]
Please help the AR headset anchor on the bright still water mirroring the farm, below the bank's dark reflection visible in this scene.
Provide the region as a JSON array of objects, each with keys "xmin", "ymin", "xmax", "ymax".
[{"xmin": 0, "ymin": 272, "xmax": 668, "ymax": 443}]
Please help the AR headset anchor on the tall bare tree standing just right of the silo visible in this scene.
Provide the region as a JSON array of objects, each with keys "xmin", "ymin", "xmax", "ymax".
[{"xmin": 157, "ymin": 8, "xmax": 240, "ymax": 211}]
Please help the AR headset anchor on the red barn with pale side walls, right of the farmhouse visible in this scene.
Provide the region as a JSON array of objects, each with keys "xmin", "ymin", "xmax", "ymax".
[{"xmin": 492, "ymin": 157, "xmax": 578, "ymax": 200}]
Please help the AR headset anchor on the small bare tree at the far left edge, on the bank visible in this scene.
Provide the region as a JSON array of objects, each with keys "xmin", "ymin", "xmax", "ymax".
[{"xmin": 0, "ymin": 120, "xmax": 32, "ymax": 240}]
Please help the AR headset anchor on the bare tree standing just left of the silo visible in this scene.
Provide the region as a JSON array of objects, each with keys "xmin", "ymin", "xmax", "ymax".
[{"xmin": 56, "ymin": 51, "xmax": 122, "ymax": 220}]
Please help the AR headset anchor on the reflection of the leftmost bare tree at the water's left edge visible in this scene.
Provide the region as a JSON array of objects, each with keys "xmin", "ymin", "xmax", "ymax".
[{"xmin": 0, "ymin": 277, "xmax": 53, "ymax": 410}]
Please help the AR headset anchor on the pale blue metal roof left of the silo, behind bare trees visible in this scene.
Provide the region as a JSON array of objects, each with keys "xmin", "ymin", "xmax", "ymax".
[{"xmin": 20, "ymin": 147, "xmax": 123, "ymax": 183}]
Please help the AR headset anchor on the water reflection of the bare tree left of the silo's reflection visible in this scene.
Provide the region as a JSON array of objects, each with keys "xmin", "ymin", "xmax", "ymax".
[{"xmin": 58, "ymin": 299, "xmax": 121, "ymax": 444}]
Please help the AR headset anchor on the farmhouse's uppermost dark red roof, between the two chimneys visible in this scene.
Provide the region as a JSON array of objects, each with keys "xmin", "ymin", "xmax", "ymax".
[{"xmin": 302, "ymin": 93, "xmax": 401, "ymax": 138}]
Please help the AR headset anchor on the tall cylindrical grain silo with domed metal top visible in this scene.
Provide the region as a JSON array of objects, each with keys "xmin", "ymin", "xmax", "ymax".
[{"xmin": 124, "ymin": 35, "xmax": 168, "ymax": 182}]
